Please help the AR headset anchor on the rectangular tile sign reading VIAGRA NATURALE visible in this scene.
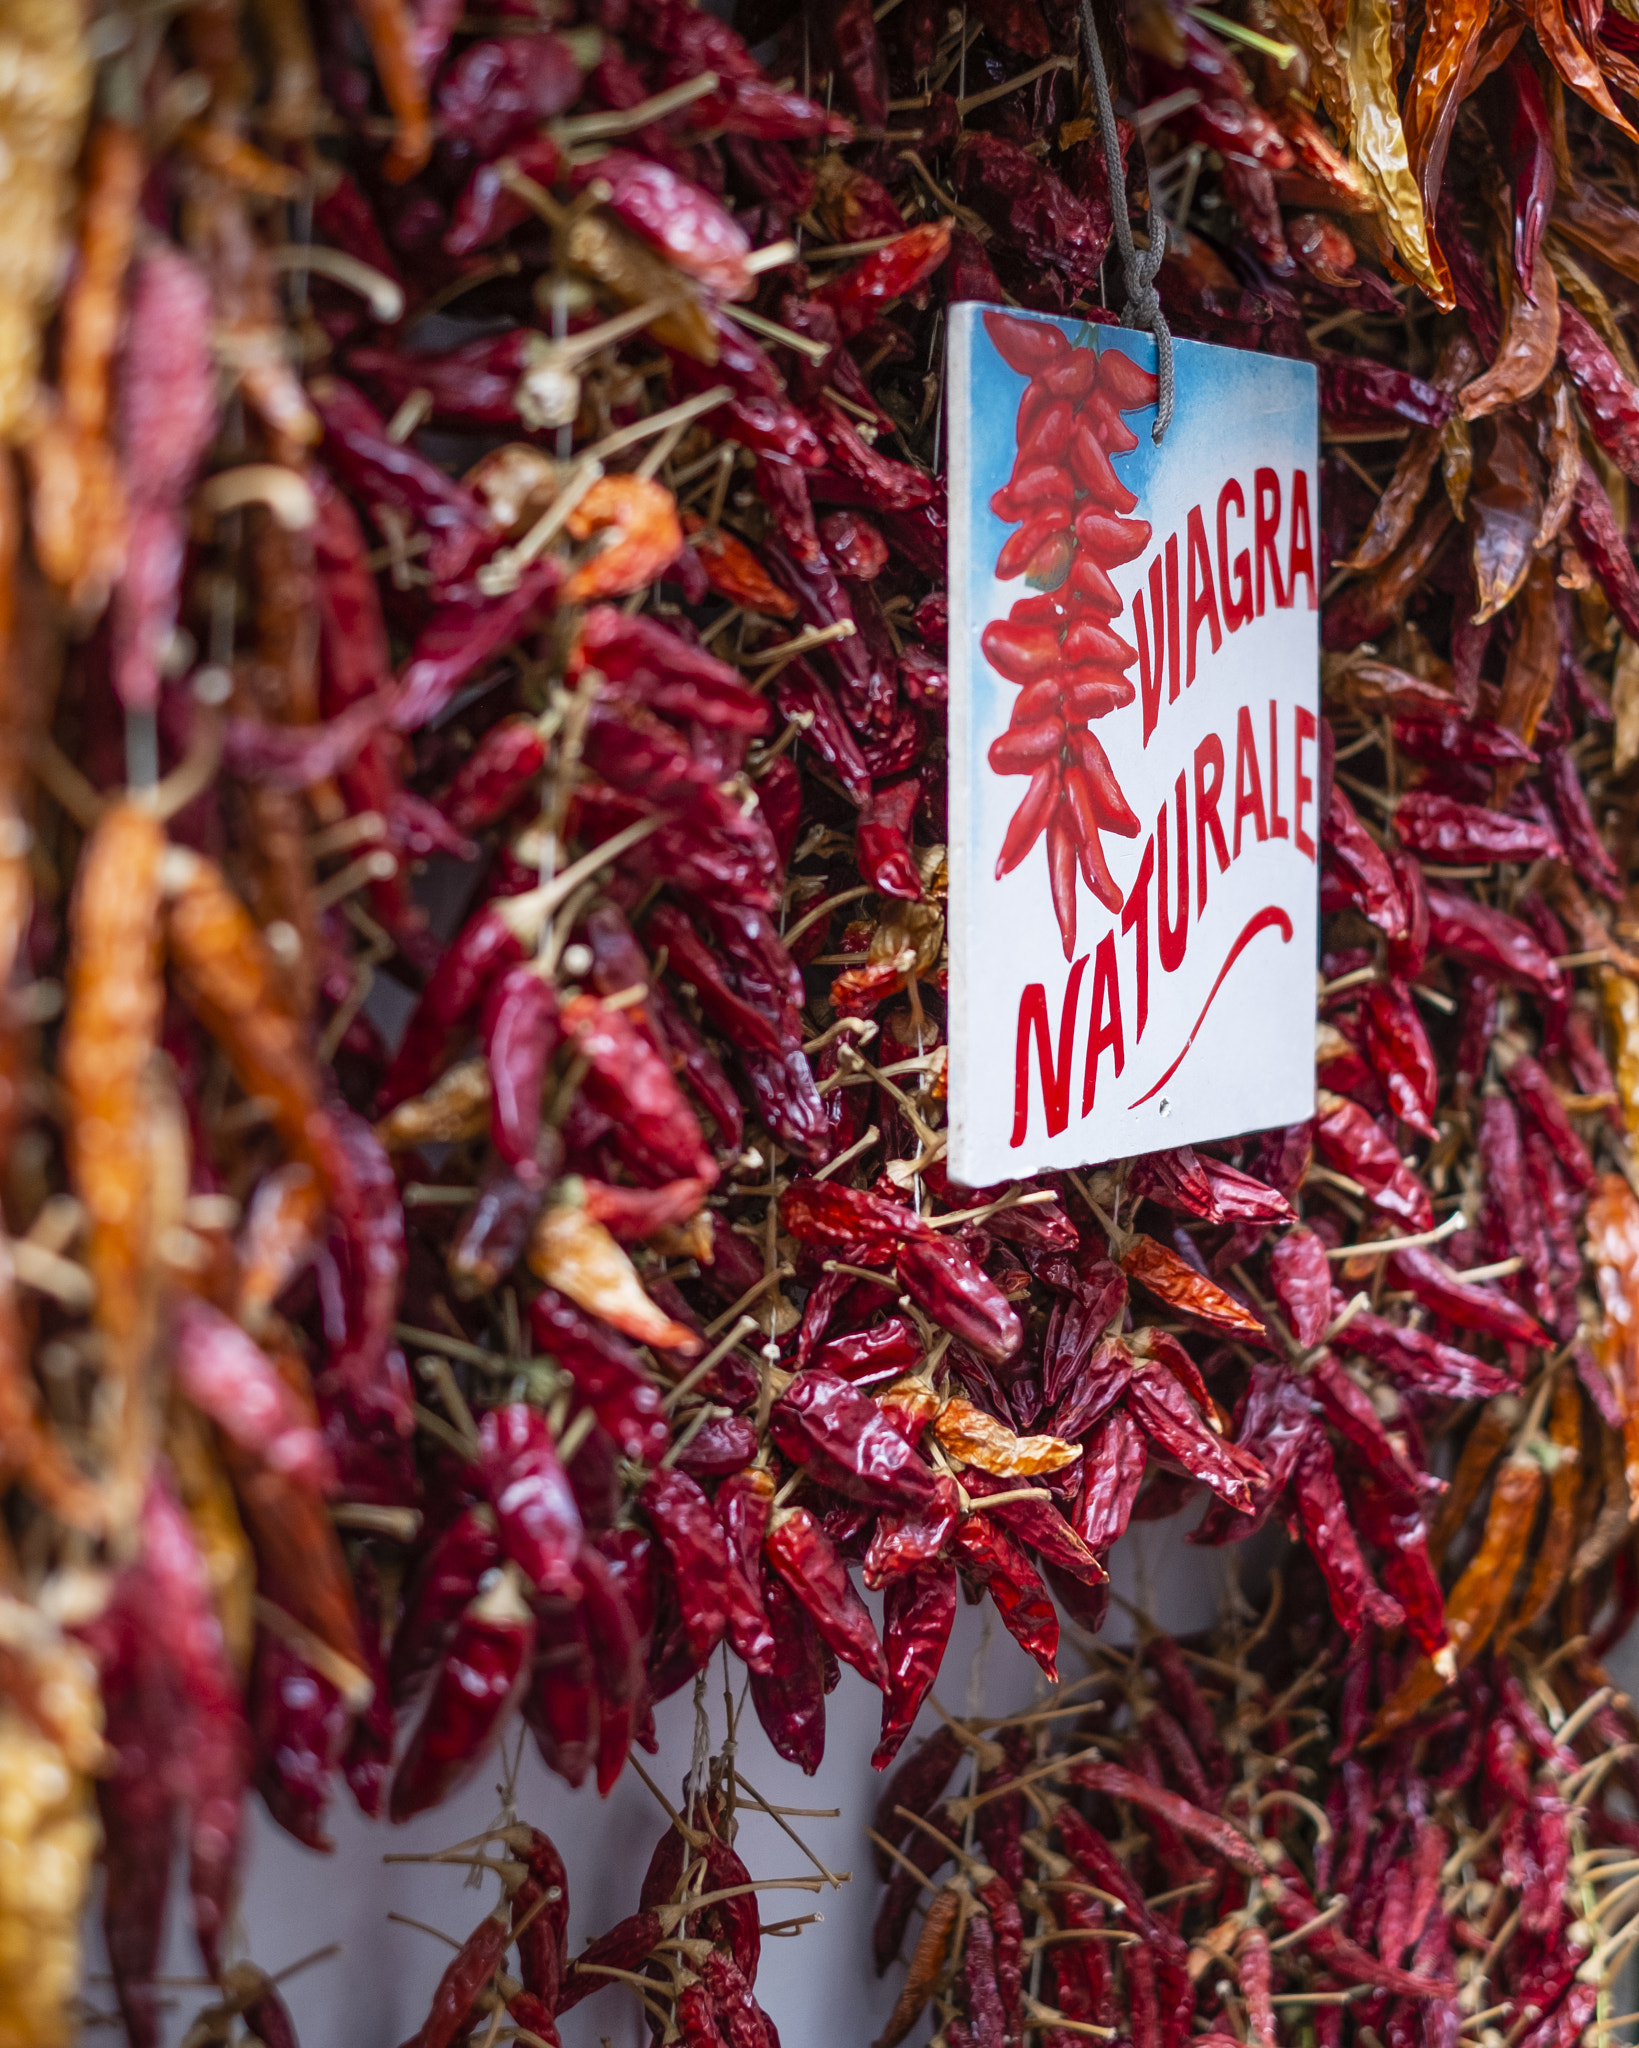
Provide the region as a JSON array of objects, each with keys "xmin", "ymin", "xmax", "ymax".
[{"xmin": 949, "ymin": 305, "xmax": 1319, "ymax": 1186}]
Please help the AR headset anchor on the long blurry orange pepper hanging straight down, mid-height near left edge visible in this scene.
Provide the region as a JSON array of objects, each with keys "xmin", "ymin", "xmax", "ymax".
[{"xmin": 57, "ymin": 801, "xmax": 166, "ymax": 1511}]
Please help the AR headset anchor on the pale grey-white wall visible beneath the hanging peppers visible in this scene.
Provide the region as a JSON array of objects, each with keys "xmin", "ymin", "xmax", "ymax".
[{"xmin": 86, "ymin": 1516, "xmax": 1231, "ymax": 2048}]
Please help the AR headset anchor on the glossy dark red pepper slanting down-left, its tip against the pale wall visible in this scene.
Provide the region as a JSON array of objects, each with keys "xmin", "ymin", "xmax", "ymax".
[{"xmin": 387, "ymin": 1577, "xmax": 535, "ymax": 1823}]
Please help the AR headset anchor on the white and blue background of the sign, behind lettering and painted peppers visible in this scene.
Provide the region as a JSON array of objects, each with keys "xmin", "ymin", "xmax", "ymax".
[{"xmin": 949, "ymin": 305, "xmax": 1319, "ymax": 1186}]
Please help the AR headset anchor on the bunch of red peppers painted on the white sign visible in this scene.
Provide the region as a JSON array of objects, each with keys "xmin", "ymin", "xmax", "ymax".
[{"xmin": 981, "ymin": 313, "xmax": 1155, "ymax": 961}]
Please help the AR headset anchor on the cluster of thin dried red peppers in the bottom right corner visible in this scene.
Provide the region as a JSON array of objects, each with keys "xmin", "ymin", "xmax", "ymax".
[{"xmin": 871, "ymin": 1605, "xmax": 1639, "ymax": 2048}]
